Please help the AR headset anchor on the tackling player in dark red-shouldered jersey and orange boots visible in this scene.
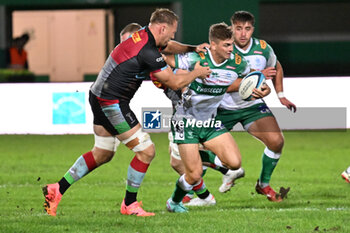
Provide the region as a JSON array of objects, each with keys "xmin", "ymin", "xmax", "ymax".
[{"xmin": 43, "ymin": 9, "xmax": 211, "ymax": 216}]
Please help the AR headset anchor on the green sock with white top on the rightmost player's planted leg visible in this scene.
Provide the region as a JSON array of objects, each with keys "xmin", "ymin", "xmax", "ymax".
[{"xmin": 259, "ymin": 147, "xmax": 281, "ymax": 188}]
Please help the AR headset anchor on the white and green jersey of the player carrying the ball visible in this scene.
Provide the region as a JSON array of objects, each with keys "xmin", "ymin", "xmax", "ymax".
[{"xmin": 175, "ymin": 50, "xmax": 250, "ymax": 121}]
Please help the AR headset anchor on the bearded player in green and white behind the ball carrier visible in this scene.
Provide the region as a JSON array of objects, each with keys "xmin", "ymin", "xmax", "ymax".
[{"xmin": 218, "ymin": 11, "xmax": 296, "ymax": 202}]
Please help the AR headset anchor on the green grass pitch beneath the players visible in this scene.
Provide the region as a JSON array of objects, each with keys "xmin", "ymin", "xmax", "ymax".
[{"xmin": 0, "ymin": 131, "xmax": 350, "ymax": 233}]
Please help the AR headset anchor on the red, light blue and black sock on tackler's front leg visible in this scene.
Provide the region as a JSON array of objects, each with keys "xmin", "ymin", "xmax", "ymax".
[{"xmin": 124, "ymin": 156, "xmax": 149, "ymax": 206}]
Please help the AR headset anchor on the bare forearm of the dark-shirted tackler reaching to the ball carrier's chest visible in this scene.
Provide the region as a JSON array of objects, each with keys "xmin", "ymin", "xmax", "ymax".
[{"xmin": 153, "ymin": 62, "xmax": 211, "ymax": 90}]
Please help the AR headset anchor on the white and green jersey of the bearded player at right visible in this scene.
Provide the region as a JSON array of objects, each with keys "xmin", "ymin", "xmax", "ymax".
[{"xmin": 219, "ymin": 38, "xmax": 277, "ymax": 110}]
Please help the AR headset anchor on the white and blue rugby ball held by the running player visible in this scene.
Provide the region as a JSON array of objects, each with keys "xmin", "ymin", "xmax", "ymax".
[{"xmin": 238, "ymin": 71, "xmax": 265, "ymax": 101}]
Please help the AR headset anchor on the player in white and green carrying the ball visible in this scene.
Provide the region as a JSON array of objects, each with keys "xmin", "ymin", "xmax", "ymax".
[{"xmin": 167, "ymin": 23, "xmax": 250, "ymax": 213}]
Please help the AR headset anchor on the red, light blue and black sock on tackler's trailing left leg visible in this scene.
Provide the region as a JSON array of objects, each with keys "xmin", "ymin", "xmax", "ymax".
[{"xmin": 58, "ymin": 151, "xmax": 97, "ymax": 195}]
